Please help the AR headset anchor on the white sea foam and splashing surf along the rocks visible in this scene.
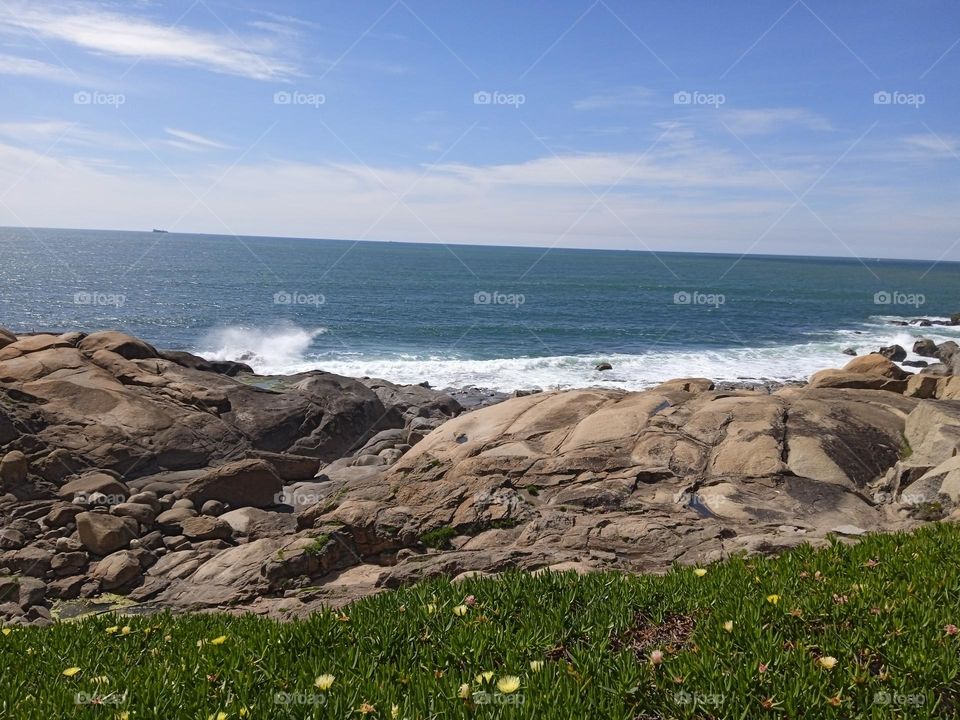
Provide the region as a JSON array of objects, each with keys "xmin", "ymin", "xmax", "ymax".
[{"xmin": 200, "ymin": 317, "xmax": 960, "ymax": 392}]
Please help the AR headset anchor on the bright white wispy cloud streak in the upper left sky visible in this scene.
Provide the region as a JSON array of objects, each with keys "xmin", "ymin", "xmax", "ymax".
[{"xmin": 0, "ymin": 1, "xmax": 297, "ymax": 81}]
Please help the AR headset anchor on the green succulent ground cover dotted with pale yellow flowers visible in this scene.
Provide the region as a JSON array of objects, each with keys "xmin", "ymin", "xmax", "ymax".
[{"xmin": 0, "ymin": 524, "xmax": 960, "ymax": 720}]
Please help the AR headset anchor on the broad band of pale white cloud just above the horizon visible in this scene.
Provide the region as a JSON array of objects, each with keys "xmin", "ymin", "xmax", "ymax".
[{"xmin": 0, "ymin": 126, "xmax": 960, "ymax": 259}]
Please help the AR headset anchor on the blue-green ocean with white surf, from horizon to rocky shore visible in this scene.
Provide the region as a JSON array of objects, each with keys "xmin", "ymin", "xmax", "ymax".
[{"xmin": 0, "ymin": 228, "xmax": 960, "ymax": 391}]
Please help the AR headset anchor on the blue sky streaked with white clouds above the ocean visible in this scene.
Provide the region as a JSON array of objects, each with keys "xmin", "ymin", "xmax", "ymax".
[{"xmin": 0, "ymin": 0, "xmax": 960, "ymax": 260}]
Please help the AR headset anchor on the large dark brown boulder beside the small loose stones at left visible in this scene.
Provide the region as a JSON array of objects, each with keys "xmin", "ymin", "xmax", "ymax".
[{"xmin": 183, "ymin": 460, "xmax": 283, "ymax": 508}]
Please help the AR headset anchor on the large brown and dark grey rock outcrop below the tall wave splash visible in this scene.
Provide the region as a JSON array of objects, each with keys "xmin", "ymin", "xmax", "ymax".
[{"xmin": 0, "ymin": 332, "xmax": 404, "ymax": 482}]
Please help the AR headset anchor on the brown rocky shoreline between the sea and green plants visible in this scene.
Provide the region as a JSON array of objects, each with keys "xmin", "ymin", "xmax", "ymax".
[{"xmin": 0, "ymin": 329, "xmax": 960, "ymax": 624}]
